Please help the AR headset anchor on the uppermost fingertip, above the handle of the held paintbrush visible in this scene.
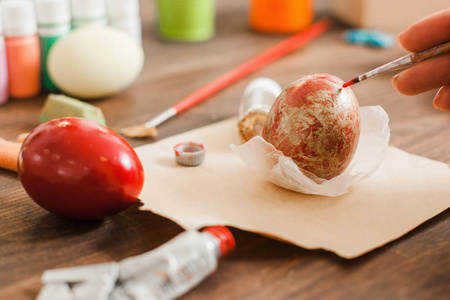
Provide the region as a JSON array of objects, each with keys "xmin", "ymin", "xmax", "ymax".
[{"xmin": 397, "ymin": 8, "xmax": 450, "ymax": 52}]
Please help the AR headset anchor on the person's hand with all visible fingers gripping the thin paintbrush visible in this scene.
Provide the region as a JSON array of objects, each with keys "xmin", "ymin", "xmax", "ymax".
[{"xmin": 392, "ymin": 8, "xmax": 450, "ymax": 111}]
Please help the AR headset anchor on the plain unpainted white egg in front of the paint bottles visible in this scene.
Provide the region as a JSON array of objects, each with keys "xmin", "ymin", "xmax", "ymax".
[{"xmin": 47, "ymin": 27, "xmax": 144, "ymax": 99}]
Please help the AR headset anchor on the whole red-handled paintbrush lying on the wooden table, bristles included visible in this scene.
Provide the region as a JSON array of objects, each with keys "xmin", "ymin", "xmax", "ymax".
[{"xmin": 120, "ymin": 18, "xmax": 331, "ymax": 138}]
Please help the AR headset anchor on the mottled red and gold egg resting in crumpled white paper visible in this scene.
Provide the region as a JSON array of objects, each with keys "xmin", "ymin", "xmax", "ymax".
[{"xmin": 262, "ymin": 74, "xmax": 360, "ymax": 179}]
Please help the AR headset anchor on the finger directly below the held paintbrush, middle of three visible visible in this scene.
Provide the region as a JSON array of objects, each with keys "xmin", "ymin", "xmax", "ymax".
[{"xmin": 392, "ymin": 53, "xmax": 450, "ymax": 95}]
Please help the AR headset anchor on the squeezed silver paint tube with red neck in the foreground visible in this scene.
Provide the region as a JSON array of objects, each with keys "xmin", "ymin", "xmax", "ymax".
[{"xmin": 37, "ymin": 226, "xmax": 235, "ymax": 300}]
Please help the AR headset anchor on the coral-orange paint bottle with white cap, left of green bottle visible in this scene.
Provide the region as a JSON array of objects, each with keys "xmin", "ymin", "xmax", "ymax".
[{"xmin": 1, "ymin": 0, "xmax": 41, "ymax": 98}]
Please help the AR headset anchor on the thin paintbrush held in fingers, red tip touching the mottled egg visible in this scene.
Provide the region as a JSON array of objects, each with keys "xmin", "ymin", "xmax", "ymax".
[{"xmin": 342, "ymin": 41, "xmax": 450, "ymax": 88}]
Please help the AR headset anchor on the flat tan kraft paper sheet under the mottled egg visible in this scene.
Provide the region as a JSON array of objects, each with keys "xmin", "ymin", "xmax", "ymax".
[{"xmin": 136, "ymin": 118, "xmax": 450, "ymax": 258}]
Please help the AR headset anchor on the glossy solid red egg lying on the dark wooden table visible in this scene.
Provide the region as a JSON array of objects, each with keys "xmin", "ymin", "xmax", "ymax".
[{"xmin": 18, "ymin": 118, "xmax": 144, "ymax": 220}]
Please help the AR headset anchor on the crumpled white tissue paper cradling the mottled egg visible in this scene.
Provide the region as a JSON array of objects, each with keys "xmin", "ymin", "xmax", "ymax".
[{"xmin": 231, "ymin": 106, "xmax": 390, "ymax": 197}]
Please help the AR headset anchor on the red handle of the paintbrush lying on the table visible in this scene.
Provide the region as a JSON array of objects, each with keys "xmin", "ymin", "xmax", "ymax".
[{"xmin": 173, "ymin": 19, "xmax": 331, "ymax": 113}]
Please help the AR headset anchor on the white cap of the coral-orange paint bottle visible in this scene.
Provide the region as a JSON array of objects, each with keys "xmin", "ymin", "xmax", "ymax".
[{"xmin": 1, "ymin": 0, "xmax": 37, "ymax": 37}]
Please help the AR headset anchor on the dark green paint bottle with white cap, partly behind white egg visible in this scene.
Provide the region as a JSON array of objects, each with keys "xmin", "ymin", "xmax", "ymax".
[{"xmin": 36, "ymin": 0, "xmax": 70, "ymax": 92}]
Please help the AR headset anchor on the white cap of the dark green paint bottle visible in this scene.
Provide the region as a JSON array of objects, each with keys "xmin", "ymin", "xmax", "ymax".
[{"xmin": 36, "ymin": 0, "xmax": 70, "ymax": 25}]
